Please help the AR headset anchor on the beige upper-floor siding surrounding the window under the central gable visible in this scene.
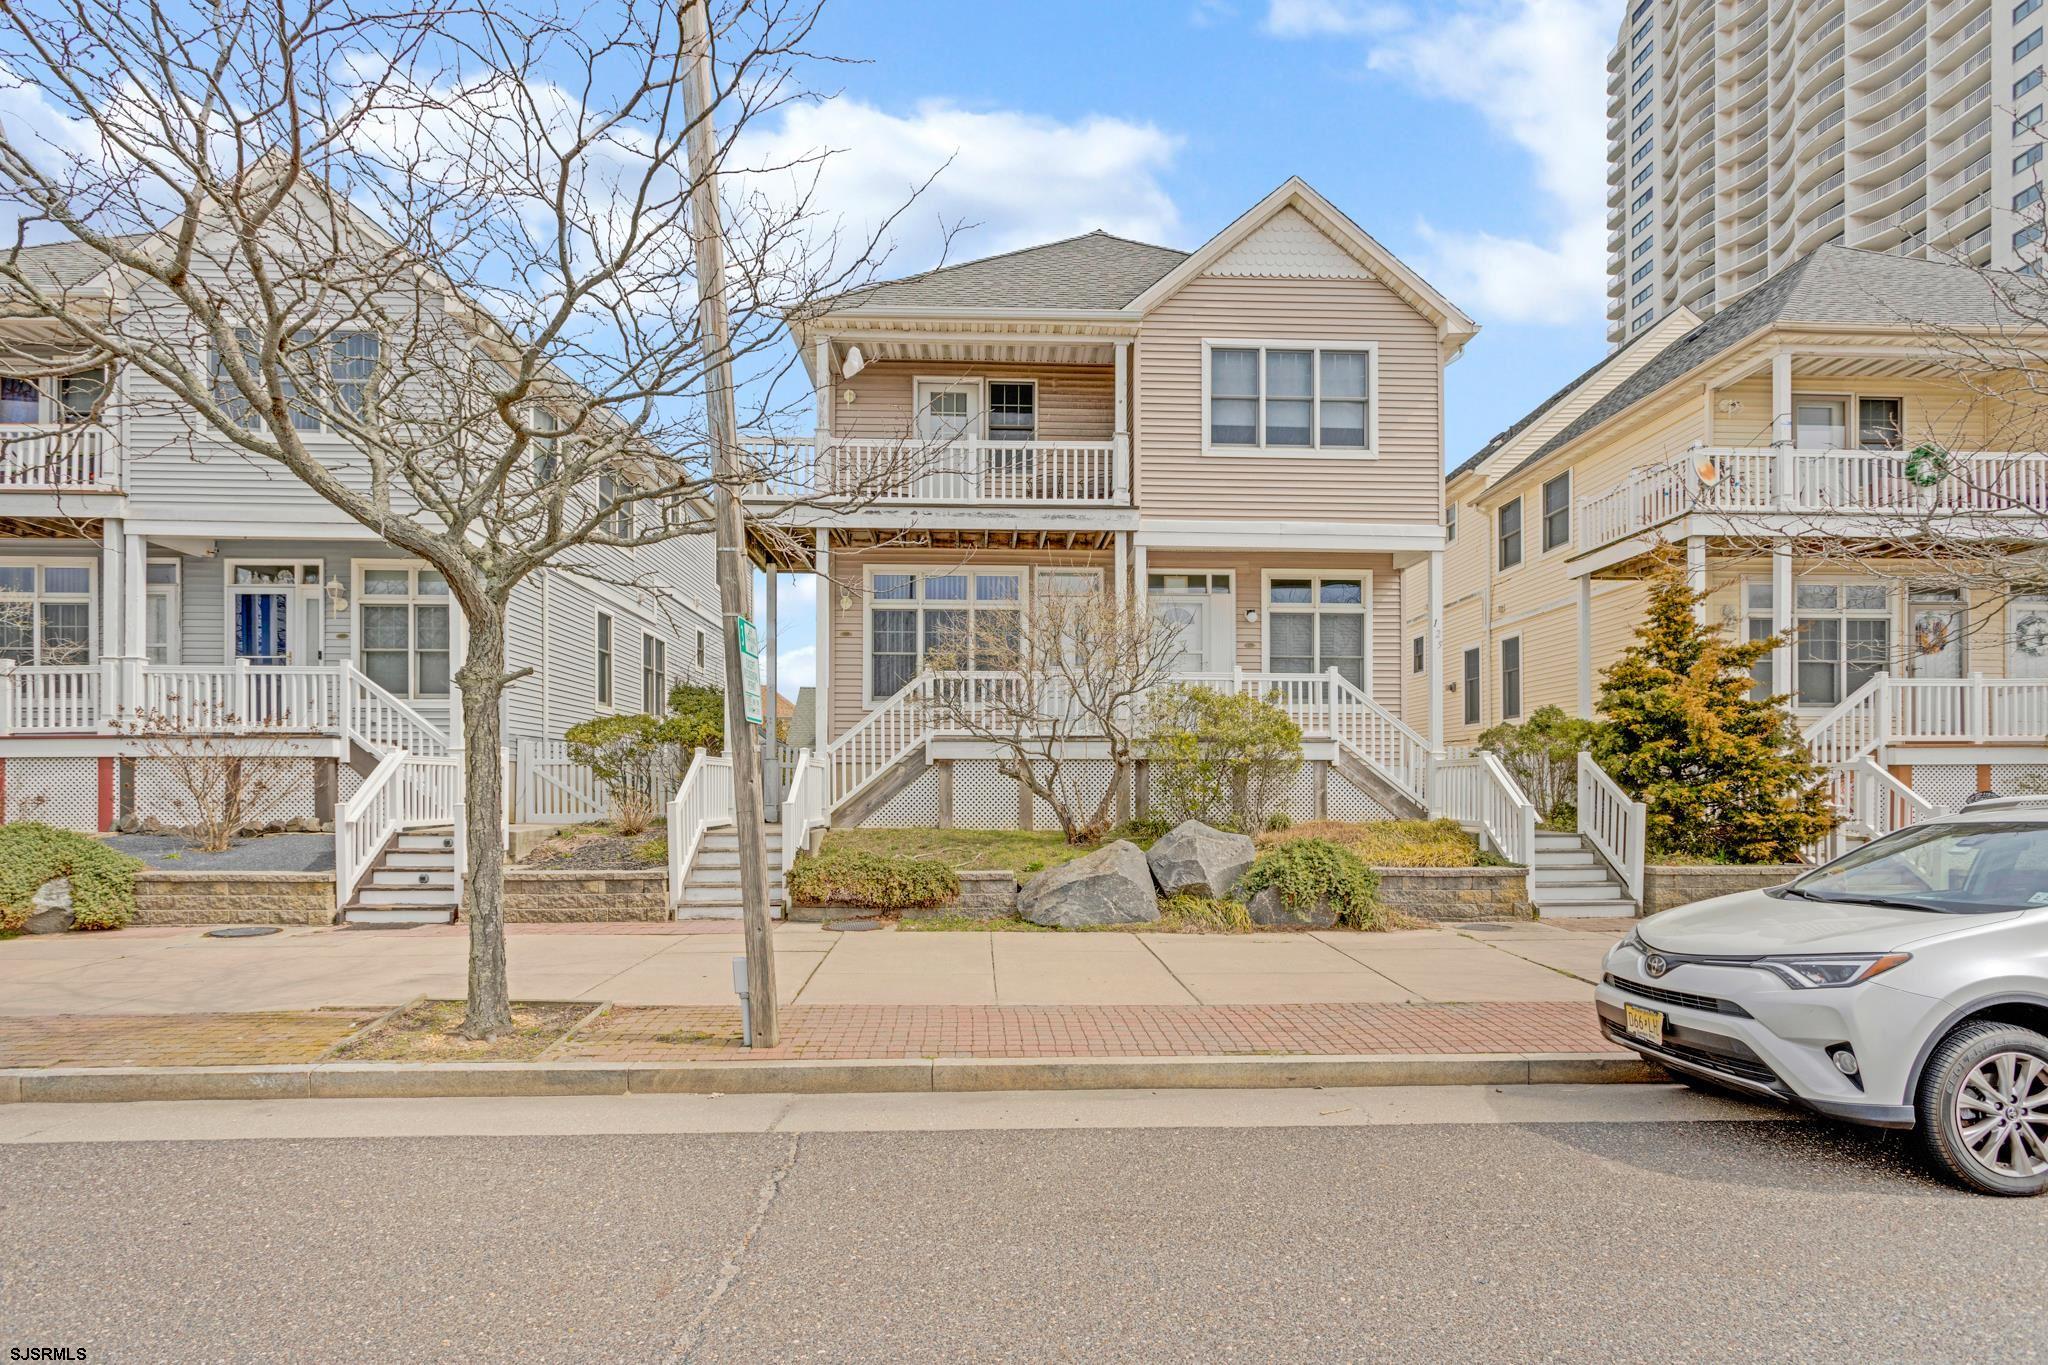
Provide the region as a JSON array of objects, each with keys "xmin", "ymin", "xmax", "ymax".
[{"xmin": 1137, "ymin": 276, "xmax": 1444, "ymax": 524}]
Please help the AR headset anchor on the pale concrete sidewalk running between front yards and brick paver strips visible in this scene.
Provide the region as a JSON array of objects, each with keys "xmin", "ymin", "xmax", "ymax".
[{"xmin": 0, "ymin": 921, "xmax": 1622, "ymax": 1017}]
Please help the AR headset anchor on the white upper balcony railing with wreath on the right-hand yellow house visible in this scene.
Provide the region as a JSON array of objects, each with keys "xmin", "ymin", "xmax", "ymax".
[{"xmin": 1579, "ymin": 448, "xmax": 2048, "ymax": 548}]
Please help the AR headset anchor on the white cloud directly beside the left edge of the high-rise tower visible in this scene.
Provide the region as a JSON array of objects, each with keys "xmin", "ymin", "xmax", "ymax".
[{"xmin": 1268, "ymin": 0, "xmax": 1614, "ymax": 323}]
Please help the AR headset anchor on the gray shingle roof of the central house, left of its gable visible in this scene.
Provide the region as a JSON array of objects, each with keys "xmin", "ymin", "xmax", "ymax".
[{"xmin": 829, "ymin": 229, "xmax": 1188, "ymax": 313}]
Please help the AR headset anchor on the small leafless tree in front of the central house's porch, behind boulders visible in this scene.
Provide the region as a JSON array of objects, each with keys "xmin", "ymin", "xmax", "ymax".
[{"xmin": 913, "ymin": 575, "xmax": 1180, "ymax": 843}]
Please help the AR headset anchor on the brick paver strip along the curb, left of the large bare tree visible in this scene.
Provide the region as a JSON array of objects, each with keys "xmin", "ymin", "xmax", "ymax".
[{"xmin": 0, "ymin": 1009, "xmax": 387, "ymax": 1066}]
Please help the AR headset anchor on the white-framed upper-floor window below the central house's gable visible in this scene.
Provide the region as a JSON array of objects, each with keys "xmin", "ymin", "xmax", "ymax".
[{"xmin": 1208, "ymin": 346, "xmax": 1372, "ymax": 450}]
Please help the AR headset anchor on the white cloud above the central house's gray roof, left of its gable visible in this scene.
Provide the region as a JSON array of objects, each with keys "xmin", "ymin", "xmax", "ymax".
[{"xmin": 739, "ymin": 96, "xmax": 1180, "ymax": 276}]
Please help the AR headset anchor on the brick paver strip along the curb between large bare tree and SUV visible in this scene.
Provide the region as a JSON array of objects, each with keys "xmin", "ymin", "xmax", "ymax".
[{"xmin": 555, "ymin": 1001, "xmax": 1618, "ymax": 1062}]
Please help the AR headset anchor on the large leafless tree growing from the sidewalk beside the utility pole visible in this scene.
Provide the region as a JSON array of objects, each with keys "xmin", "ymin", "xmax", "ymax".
[{"xmin": 0, "ymin": 0, "xmax": 942, "ymax": 1038}]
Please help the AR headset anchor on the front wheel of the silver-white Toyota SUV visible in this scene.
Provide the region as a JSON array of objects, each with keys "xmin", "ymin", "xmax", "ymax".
[{"xmin": 1915, "ymin": 1021, "xmax": 2048, "ymax": 1195}]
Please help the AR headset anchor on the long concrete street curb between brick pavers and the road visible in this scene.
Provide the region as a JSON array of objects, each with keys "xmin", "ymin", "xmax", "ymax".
[{"xmin": 0, "ymin": 1052, "xmax": 1663, "ymax": 1105}]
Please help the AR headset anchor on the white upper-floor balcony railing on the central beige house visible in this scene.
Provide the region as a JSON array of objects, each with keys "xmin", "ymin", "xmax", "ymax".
[{"xmin": 741, "ymin": 436, "xmax": 1130, "ymax": 508}]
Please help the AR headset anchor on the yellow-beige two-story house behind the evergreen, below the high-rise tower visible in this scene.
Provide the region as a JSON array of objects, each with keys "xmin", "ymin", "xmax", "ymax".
[{"xmin": 1403, "ymin": 246, "xmax": 2048, "ymax": 831}]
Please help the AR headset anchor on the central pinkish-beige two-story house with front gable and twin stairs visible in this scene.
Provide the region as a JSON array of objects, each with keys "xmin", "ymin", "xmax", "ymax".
[{"xmin": 750, "ymin": 180, "xmax": 1477, "ymax": 827}]
